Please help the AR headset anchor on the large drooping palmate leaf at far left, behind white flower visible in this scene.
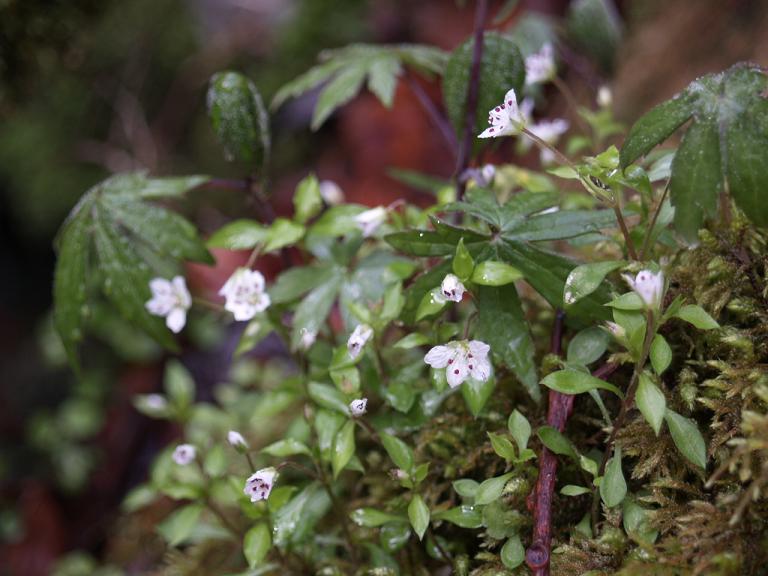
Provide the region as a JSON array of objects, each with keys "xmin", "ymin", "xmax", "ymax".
[{"xmin": 53, "ymin": 173, "xmax": 213, "ymax": 368}]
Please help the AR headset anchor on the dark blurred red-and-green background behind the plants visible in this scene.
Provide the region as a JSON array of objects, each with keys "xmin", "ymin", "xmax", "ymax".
[{"xmin": 0, "ymin": 0, "xmax": 768, "ymax": 576}]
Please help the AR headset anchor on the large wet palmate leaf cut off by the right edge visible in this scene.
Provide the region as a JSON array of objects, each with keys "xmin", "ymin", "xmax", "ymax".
[{"xmin": 621, "ymin": 64, "xmax": 768, "ymax": 242}]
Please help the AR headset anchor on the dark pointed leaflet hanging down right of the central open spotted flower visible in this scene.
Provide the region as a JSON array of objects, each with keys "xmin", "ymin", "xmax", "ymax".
[{"xmin": 475, "ymin": 284, "xmax": 541, "ymax": 400}]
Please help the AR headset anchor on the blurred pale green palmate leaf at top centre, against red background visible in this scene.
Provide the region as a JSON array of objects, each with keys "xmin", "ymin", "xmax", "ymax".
[{"xmin": 272, "ymin": 44, "xmax": 447, "ymax": 130}]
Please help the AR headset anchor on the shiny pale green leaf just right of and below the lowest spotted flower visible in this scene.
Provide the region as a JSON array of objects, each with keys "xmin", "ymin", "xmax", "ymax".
[{"xmin": 272, "ymin": 482, "xmax": 331, "ymax": 549}]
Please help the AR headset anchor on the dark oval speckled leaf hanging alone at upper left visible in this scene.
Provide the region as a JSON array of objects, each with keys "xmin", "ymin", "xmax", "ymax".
[{"xmin": 207, "ymin": 71, "xmax": 270, "ymax": 171}]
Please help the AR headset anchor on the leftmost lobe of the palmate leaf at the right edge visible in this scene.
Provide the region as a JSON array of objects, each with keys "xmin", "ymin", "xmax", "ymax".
[{"xmin": 620, "ymin": 91, "xmax": 693, "ymax": 168}]
